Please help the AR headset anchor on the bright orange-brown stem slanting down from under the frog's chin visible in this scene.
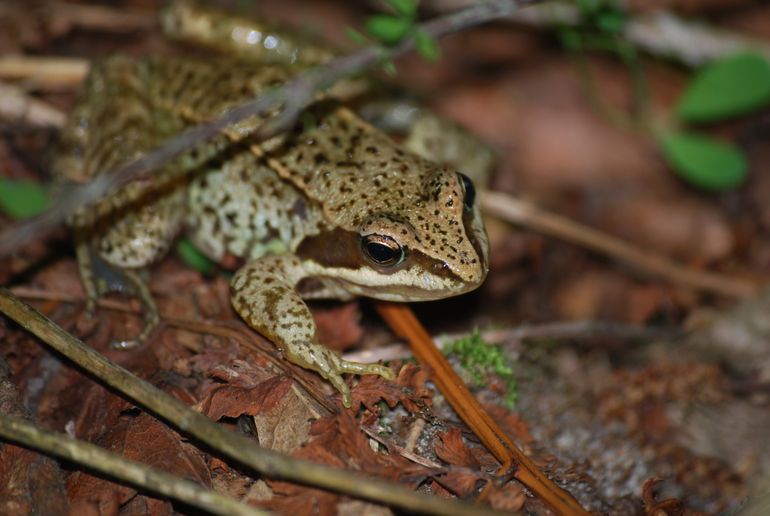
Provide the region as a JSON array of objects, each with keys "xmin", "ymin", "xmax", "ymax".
[{"xmin": 377, "ymin": 302, "xmax": 588, "ymax": 515}]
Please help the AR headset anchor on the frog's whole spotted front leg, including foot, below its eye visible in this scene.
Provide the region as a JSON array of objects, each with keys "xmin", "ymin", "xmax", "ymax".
[{"xmin": 230, "ymin": 254, "xmax": 394, "ymax": 407}]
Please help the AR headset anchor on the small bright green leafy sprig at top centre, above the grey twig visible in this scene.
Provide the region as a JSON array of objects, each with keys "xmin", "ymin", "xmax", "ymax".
[{"xmin": 346, "ymin": 0, "xmax": 441, "ymax": 70}]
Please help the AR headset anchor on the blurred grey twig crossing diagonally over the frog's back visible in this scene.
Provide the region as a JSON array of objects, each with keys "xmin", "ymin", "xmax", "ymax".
[{"xmin": 0, "ymin": 0, "xmax": 539, "ymax": 256}]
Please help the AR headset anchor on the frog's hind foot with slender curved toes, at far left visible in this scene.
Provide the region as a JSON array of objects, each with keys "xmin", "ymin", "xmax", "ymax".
[{"xmin": 77, "ymin": 243, "xmax": 160, "ymax": 349}]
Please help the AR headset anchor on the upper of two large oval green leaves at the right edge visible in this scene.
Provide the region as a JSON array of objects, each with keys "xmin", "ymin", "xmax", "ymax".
[{"xmin": 677, "ymin": 53, "xmax": 770, "ymax": 122}]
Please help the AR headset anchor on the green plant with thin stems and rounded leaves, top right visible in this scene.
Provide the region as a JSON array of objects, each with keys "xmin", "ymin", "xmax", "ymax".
[{"xmin": 558, "ymin": 0, "xmax": 770, "ymax": 192}]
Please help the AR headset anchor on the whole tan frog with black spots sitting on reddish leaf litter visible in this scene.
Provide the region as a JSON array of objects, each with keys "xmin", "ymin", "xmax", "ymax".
[{"xmin": 55, "ymin": 0, "xmax": 487, "ymax": 406}]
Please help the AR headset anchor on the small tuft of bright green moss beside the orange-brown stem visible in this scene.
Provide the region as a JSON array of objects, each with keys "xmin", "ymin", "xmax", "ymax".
[{"xmin": 443, "ymin": 328, "xmax": 518, "ymax": 409}]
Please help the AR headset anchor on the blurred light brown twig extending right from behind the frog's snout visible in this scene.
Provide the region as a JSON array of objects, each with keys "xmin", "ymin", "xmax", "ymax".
[{"xmin": 481, "ymin": 191, "xmax": 759, "ymax": 297}]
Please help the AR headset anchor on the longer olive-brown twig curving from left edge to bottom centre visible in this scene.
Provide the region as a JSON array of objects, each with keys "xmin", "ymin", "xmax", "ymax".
[{"xmin": 0, "ymin": 288, "xmax": 500, "ymax": 516}]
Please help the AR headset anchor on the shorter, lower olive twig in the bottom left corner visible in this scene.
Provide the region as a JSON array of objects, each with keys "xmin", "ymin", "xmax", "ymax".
[{"xmin": 0, "ymin": 414, "xmax": 269, "ymax": 516}]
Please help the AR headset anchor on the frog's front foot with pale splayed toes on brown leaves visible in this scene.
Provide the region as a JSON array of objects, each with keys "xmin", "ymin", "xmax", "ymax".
[{"xmin": 283, "ymin": 342, "xmax": 396, "ymax": 408}]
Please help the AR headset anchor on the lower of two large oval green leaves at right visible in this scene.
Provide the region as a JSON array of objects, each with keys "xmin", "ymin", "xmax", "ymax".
[{"xmin": 661, "ymin": 133, "xmax": 748, "ymax": 191}]
